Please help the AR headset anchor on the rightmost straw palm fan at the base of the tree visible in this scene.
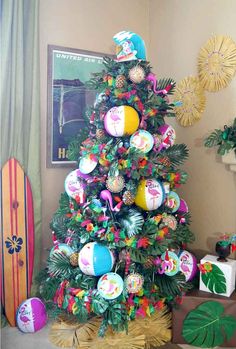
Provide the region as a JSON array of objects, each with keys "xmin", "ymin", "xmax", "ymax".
[{"xmin": 129, "ymin": 307, "xmax": 171, "ymax": 349}]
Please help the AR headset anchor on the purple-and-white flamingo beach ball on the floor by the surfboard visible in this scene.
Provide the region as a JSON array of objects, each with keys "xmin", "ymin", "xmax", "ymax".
[{"xmin": 16, "ymin": 297, "xmax": 47, "ymax": 333}]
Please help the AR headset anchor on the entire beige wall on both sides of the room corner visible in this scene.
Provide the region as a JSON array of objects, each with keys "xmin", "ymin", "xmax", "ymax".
[{"xmin": 40, "ymin": 0, "xmax": 236, "ymax": 260}]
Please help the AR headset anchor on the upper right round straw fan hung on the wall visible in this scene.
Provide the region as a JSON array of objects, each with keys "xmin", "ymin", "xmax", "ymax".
[{"xmin": 198, "ymin": 35, "xmax": 236, "ymax": 92}]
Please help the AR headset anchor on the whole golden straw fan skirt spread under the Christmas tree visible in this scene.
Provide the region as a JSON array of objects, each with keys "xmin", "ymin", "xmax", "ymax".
[{"xmin": 49, "ymin": 307, "xmax": 171, "ymax": 349}]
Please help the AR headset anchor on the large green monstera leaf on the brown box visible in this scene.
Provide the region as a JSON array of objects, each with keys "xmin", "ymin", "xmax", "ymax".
[{"xmin": 182, "ymin": 301, "xmax": 236, "ymax": 348}]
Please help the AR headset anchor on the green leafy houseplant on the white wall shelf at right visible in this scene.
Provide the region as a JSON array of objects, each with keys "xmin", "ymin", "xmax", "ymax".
[{"xmin": 204, "ymin": 118, "xmax": 236, "ymax": 155}]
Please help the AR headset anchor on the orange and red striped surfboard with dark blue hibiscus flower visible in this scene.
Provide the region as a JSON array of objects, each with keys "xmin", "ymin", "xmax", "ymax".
[{"xmin": 0, "ymin": 158, "xmax": 34, "ymax": 326}]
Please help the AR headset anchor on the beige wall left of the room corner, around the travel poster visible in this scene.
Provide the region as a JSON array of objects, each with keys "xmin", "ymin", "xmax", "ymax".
[{"xmin": 40, "ymin": 0, "xmax": 149, "ymax": 260}]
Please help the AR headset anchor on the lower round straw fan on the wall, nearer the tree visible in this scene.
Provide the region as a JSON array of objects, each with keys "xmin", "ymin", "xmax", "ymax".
[{"xmin": 173, "ymin": 76, "xmax": 206, "ymax": 126}]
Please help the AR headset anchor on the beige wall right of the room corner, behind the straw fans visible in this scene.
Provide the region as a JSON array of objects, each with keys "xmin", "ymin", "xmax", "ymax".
[{"xmin": 149, "ymin": 0, "xmax": 236, "ymax": 252}]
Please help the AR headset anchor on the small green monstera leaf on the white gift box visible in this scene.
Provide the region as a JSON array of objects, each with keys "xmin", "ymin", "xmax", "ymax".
[{"xmin": 201, "ymin": 264, "xmax": 226, "ymax": 293}]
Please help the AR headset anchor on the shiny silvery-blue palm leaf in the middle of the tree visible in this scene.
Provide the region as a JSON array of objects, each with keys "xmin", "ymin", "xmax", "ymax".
[{"xmin": 119, "ymin": 208, "xmax": 144, "ymax": 237}]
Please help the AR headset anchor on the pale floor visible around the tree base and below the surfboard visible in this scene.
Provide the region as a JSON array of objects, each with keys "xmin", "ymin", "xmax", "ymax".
[{"xmin": 0, "ymin": 324, "xmax": 231, "ymax": 349}]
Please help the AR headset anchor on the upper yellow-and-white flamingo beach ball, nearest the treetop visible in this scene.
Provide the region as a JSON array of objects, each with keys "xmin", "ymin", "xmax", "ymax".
[{"xmin": 104, "ymin": 105, "xmax": 139, "ymax": 137}]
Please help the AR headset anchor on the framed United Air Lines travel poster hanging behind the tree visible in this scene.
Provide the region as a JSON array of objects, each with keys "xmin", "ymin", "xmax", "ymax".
[{"xmin": 47, "ymin": 45, "xmax": 111, "ymax": 167}]
